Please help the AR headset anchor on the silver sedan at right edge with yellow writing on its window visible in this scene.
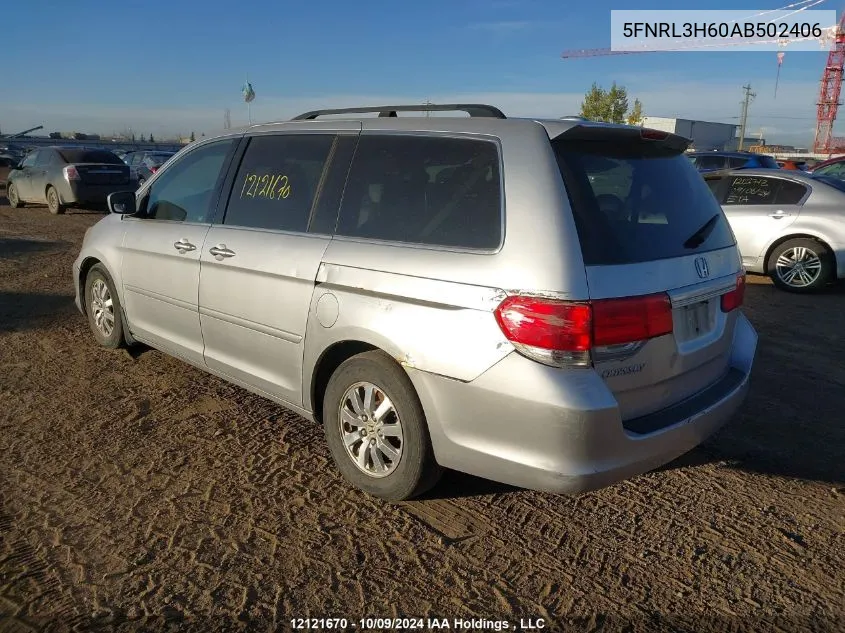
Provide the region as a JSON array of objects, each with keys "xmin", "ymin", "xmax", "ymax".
[{"xmin": 705, "ymin": 169, "xmax": 845, "ymax": 292}]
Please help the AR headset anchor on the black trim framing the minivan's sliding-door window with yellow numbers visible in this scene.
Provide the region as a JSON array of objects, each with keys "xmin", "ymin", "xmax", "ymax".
[{"xmin": 212, "ymin": 128, "xmax": 360, "ymax": 239}]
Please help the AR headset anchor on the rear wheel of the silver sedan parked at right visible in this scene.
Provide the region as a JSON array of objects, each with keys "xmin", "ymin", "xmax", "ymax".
[{"xmin": 767, "ymin": 238, "xmax": 836, "ymax": 294}]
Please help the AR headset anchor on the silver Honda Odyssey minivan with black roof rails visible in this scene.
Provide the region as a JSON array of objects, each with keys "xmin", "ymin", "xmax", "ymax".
[{"xmin": 73, "ymin": 104, "xmax": 757, "ymax": 501}]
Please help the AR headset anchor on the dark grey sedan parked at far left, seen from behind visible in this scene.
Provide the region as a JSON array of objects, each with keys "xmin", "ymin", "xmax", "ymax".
[{"xmin": 6, "ymin": 147, "xmax": 130, "ymax": 214}]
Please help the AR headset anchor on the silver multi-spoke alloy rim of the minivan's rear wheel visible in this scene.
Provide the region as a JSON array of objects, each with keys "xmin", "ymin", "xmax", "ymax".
[{"xmin": 338, "ymin": 382, "xmax": 405, "ymax": 478}]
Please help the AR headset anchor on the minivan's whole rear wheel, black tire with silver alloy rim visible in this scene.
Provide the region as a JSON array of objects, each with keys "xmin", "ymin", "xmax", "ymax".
[{"xmin": 323, "ymin": 351, "xmax": 441, "ymax": 501}]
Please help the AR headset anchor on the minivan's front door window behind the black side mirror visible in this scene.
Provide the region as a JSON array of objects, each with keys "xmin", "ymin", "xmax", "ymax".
[{"xmin": 141, "ymin": 139, "xmax": 234, "ymax": 222}]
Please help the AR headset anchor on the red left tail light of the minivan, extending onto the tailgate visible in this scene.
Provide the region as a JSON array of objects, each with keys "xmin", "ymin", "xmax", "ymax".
[{"xmin": 495, "ymin": 293, "xmax": 673, "ymax": 367}]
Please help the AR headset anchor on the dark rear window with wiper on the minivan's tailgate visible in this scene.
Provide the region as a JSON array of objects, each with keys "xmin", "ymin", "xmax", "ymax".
[{"xmin": 554, "ymin": 140, "xmax": 735, "ymax": 266}]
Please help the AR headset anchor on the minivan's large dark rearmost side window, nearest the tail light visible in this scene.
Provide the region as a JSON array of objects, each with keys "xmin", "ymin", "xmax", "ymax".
[{"xmin": 337, "ymin": 135, "xmax": 502, "ymax": 249}]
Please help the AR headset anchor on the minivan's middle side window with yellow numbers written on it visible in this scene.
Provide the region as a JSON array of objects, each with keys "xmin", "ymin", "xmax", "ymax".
[{"xmin": 223, "ymin": 134, "xmax": 337, "ymax": 232}]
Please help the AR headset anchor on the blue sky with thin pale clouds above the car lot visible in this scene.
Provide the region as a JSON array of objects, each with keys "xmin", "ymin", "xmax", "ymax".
[{"xmin": 0, "ymin": 0, "xmax": 845, "ymax": 144}]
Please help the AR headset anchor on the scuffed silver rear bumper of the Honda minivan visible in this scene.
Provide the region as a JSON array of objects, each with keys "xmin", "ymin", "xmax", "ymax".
[{"xmin": 408, "ymin": 314, "xmax": 757, "ymax": 493}]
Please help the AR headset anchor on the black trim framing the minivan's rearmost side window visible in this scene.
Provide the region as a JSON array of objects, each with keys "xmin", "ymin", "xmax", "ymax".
[{"xmin": 332, "ymin": 130, "xmax": 506, "ymax": 255}]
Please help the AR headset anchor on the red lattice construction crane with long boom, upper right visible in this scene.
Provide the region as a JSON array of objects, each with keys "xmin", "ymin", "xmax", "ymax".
[{"xmin": 561, "ymin": 12, "xmax": 845, "ymax": 154}]
